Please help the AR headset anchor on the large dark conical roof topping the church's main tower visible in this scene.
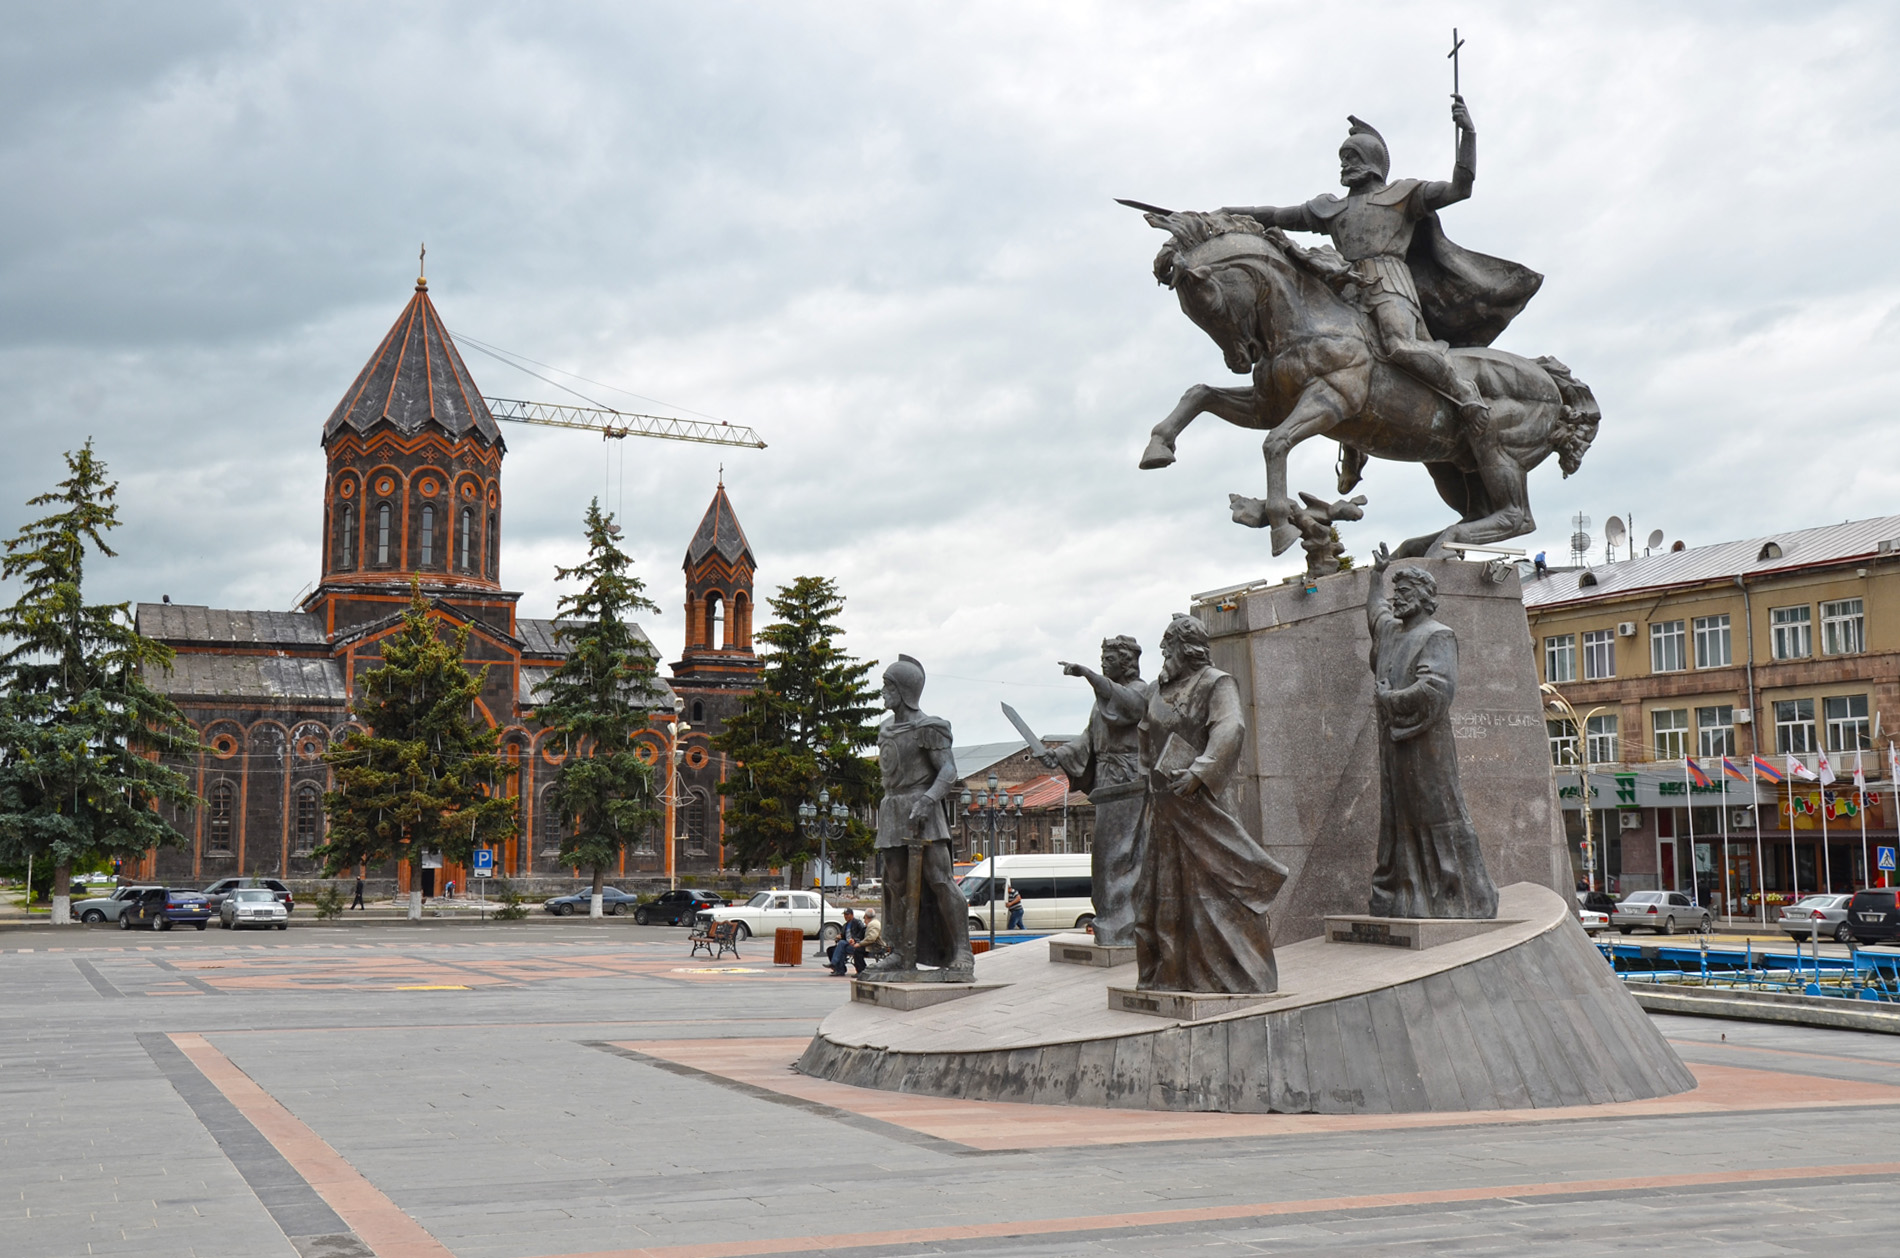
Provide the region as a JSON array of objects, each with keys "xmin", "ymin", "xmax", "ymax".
[{"xmin": 323, "ymin": 279, "xmax": 502, "ymax": 445}]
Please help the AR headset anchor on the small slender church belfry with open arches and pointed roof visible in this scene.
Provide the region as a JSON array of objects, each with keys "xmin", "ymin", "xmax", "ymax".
[{"xmin": 673, "ymin": 479, "xmax": 758, "ymax": 690}]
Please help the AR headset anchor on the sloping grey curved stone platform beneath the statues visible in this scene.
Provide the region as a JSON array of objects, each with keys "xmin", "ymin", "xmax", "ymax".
[{"xmin": 798, "ymin": 882, "xmax": 1695, "ymax": 1114}]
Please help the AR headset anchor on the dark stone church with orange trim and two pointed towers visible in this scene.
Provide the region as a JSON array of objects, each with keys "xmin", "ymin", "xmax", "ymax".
[{"xmin": 135, "ymin": 279, "xmax": 760, "ymax": 893}]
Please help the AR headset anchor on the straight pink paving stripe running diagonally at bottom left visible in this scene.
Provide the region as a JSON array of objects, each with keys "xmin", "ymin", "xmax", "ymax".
[{"xmin": 171, "ymin": 1032, "xmax": 454, "ymax": 1258}]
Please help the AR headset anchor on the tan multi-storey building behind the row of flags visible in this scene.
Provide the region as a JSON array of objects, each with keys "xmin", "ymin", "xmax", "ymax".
[{"xmin": 1524, "ymin": 515, "xmax": 1900, "ymax": 910}]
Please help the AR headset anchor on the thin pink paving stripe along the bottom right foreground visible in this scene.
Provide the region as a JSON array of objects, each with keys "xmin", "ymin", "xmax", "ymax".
[{"xmin": 555, "ymin": 1161, "xmax": 1900, "ymax": 1258}]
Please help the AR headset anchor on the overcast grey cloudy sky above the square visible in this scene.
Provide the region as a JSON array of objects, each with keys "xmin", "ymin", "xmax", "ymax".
[{"xmin": 0, "ymin": 0, "xmax": 1900, "ymax": 743}]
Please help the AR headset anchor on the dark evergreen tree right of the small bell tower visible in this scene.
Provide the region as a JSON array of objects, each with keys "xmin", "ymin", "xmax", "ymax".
[{"xmin": 713, "ymin": 576, "xmax": 882, "ymax": 868}]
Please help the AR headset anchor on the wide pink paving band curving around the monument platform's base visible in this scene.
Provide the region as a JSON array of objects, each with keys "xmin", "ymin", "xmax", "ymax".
[{"xmin": 616, "ymin": 1038, "xmax": 1900, "ymax": 1152}]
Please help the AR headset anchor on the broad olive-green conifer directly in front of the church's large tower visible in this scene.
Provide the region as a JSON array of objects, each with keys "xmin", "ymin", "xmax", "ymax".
[{"xmin": 315, "ymin": 583, "xmax": 517, "ymax": 918}]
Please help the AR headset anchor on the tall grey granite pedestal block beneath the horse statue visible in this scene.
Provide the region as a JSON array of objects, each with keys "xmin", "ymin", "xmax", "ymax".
[{"xmin": 1193, "ymin": 559, "xmax": 1571, "ymax": 946}]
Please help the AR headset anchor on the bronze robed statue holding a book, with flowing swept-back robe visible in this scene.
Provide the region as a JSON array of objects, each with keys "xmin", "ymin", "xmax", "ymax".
[{"xmin": 1134, "ymin": 616, "xmax": 1286, "ymax": 992}]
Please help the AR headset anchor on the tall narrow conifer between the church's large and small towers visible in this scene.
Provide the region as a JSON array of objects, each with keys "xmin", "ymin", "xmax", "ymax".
[{"xmin": 534, "ymin": 498, "xmax": 661, "ymax": 918}]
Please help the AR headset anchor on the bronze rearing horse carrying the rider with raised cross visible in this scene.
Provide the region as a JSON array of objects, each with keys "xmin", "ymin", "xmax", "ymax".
[{"xmin": 1142, "ymin": 213, "xmax": 1602, "ymax": 557}]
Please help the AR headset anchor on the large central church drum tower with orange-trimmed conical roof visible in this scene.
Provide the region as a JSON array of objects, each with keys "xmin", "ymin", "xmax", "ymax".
[{"xmin": 302, "ymin": 277, "xmax": 515, "ymax": 635}]
